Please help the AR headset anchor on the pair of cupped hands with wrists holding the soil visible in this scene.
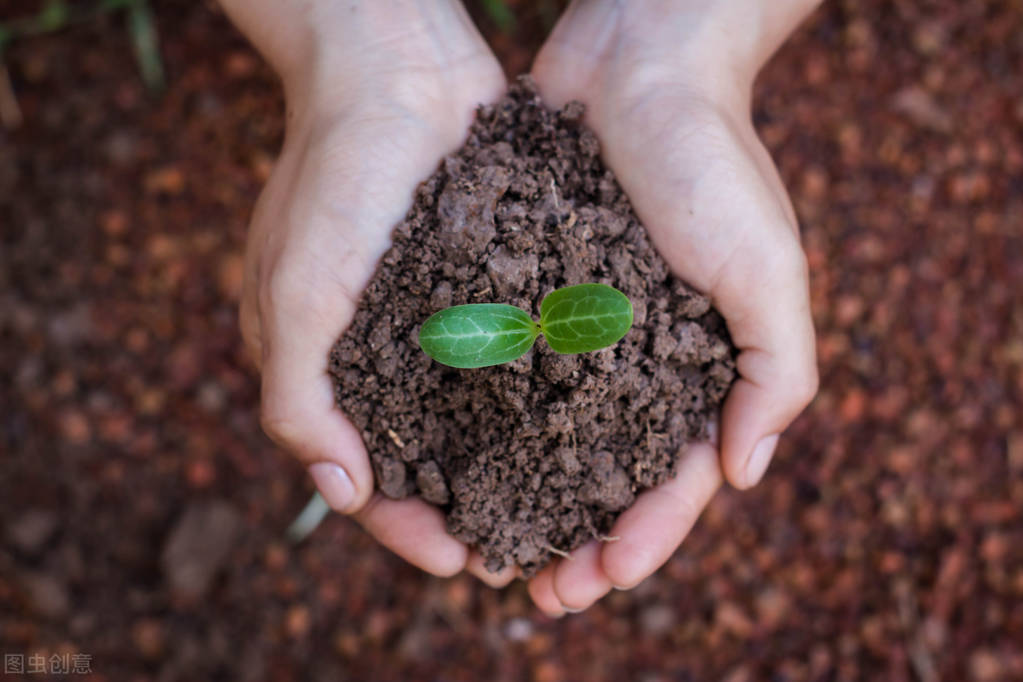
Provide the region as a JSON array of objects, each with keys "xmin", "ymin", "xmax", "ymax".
[{"xmin": 224, "ymin": 0, "xmax": 817, "ymax": 616}]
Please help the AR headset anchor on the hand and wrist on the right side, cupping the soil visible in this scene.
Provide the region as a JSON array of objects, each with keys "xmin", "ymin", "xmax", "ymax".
[{"xmin": 530, "ymin": 0, "xmax": 817, "ymax": 616}]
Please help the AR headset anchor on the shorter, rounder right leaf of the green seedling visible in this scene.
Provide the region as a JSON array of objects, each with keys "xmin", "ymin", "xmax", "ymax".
[{"xmin": 540, "ymin": 284, "xmax": 632, "ymax": 354}]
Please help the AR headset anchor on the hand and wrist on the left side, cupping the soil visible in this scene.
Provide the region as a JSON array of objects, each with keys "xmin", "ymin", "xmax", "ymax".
[{"xmin": 225, "ymin": 0, "xmax": 504, "ymax": 576}]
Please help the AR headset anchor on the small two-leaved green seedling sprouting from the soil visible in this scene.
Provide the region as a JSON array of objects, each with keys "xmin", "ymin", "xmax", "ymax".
[{"xmin": 419, "ymin": 284, "xmax": 632, "ymax": 369}]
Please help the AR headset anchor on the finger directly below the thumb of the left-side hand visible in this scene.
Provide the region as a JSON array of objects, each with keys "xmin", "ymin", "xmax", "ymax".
[{"xmin": 353, "ymin": 494, "xmax": 469, "ymax": 578}]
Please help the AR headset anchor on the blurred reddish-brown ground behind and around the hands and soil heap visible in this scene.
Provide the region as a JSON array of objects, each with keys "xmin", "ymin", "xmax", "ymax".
[{"xmin": 0, "ymin": 0, "xmax": 1023, "ymax": 682}]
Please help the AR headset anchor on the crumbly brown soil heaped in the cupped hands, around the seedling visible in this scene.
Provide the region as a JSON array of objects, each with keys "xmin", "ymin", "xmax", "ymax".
[{"xmin": 329, "ymin": 77, "xmax": 735, "ymax": 576}]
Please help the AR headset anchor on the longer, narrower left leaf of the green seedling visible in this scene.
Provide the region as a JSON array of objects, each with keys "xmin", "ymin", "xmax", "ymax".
[{"xmin": 419, "ymin": 303, "xmax": 540, "ymax": 369}]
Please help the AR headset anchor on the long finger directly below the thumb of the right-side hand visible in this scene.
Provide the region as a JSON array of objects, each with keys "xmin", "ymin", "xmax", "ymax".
[{"xmin": 601, "ymin": 444, "xmax": 721, "ymax": 589}]
